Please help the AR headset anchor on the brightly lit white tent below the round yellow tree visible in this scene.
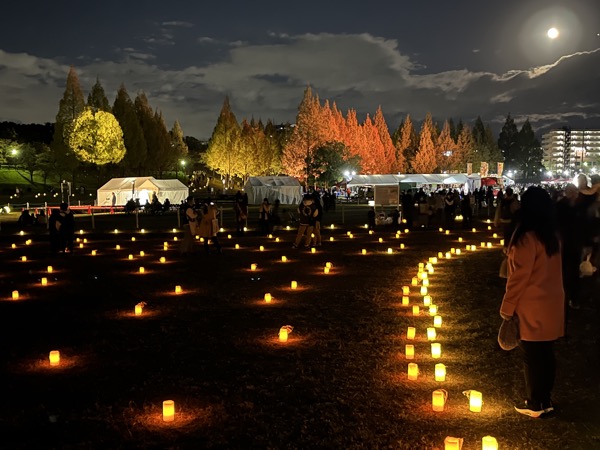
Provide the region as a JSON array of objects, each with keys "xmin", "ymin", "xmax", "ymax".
[{"xmin": 96, "ymin": 177, "xmax": 189, "ymax": 206}]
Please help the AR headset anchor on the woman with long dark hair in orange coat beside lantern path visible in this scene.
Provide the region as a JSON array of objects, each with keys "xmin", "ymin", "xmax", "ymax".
[{"xmin": 500, "ymin": 187, "xmax": 565, "ymax": 417}]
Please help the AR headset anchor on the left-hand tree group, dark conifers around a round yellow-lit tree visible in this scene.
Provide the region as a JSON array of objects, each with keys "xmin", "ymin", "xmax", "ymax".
[{"xmin": 12, "ymin": 68, "xmax": 188, "ymax": 183}]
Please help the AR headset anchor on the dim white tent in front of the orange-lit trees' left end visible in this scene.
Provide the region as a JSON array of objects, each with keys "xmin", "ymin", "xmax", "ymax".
[{"xmin": 244, "ymin": 176, "xmax": 302, "ymax": 205}]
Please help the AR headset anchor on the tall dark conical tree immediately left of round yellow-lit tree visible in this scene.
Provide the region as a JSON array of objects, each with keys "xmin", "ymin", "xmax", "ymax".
[{"xmin": 51, "ymin": 66, "xmax": 85, "ymax": 183}]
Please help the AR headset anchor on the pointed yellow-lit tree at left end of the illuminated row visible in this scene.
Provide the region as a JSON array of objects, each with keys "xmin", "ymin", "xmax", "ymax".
[{"xmin": 205, "ymin": 97, "xmax": 241, "ymax": 188}]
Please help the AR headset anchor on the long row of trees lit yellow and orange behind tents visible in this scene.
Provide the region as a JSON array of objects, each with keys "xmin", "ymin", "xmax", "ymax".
[{"xmin": 205, "ymin": 87, "xmax": 542, "ymax": 185}]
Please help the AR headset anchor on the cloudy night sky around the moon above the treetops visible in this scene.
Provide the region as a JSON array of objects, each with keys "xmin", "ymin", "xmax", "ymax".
[{"xmin": 0, "ymin": 0, "xmax": 600, "ymax": 139}]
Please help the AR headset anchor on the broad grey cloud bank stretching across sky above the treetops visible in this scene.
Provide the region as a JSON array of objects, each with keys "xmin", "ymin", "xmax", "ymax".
[{"xmin": 0, "ymin": 33, "xmax": 600, "ymax": 138}]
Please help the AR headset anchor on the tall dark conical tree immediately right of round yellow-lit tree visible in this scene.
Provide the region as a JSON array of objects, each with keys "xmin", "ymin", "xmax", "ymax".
[{"xmin": 112, "ymin": 84, "xmax": 148, "ymax": 176}]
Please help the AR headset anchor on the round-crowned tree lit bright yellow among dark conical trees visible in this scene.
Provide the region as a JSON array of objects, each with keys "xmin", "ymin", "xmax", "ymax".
[{"xmin": 65, "ymin": 108, "xmax": 125, "ymax": 166}]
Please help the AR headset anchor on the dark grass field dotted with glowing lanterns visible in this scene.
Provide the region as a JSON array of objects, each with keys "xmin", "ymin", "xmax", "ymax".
[{"xmin": 0, "ymin": 216, "xmax": 600, "ymax": 450}]
